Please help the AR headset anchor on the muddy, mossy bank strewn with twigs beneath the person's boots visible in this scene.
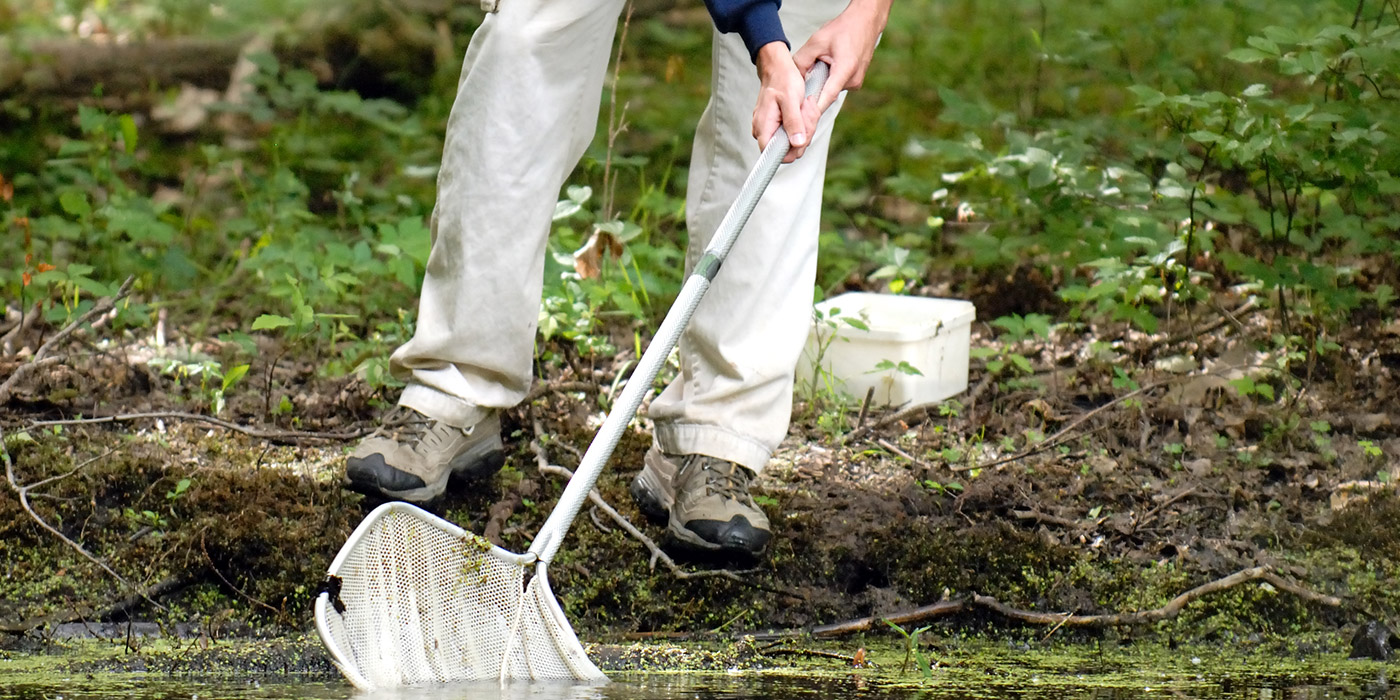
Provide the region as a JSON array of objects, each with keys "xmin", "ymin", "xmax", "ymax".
[{"xmin": 0, "ymin": 287, "xmax": 1400, "ymax": 654}]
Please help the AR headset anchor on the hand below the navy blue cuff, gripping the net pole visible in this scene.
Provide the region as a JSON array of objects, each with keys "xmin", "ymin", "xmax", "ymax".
[{"xmin": 753, "ymin": 42, "xmax": 822, "ymax": 162}]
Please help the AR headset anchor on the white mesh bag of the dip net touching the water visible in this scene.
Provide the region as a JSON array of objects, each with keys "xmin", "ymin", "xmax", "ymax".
[{"xmin": 315, "ymin": 503, "xmax": 605, "ymax": 690}]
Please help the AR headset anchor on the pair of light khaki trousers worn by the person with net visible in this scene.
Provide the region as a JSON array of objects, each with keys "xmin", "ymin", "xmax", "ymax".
[{"xmin": 391, "ymin": 0, "xmax": 846, "ymax": 472}]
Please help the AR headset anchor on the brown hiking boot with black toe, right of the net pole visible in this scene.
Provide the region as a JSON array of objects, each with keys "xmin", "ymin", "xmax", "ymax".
[{"xmin": 630, "ymin": 447, "xmax": 773, "ymax": 557}]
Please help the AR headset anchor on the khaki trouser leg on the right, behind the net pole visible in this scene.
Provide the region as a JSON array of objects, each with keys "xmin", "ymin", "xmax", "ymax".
[{"xmin": 648, "ymin": 0, "xmax": 846, "ymax": 472}]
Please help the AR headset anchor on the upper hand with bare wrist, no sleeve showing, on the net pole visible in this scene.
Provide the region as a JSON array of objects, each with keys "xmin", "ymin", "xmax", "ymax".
[{"xmin": 792, "ymin": 0, "xmax": 890, "ymax": 116}]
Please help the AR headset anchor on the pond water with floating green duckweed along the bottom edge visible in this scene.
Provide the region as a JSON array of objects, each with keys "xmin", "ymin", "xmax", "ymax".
[{"xmin": 0, "ymin": 638, "xmax": 1400, "ymax": 700}]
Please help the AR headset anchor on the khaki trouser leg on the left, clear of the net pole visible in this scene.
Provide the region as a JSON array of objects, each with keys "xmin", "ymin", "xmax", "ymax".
[{"xmin": 389, "ymin": 0, "xmax": 623, "ymax": 427}]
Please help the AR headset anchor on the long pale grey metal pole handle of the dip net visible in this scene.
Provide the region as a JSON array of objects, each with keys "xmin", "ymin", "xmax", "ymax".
[{"xmin": 529, "ymin": 62, "xmax": 830, "ymax": 563}]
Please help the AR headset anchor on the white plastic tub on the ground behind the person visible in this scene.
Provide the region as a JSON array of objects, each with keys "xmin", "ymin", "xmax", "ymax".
[{"xmin": 797, "ymin": 293, "xmax": 977, "ymax": 406}]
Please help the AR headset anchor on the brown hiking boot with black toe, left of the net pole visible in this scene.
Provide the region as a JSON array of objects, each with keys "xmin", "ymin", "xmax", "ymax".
[{"xmin": 346, "ymin": 406, "xmax": 505, "ymax": 503}]
